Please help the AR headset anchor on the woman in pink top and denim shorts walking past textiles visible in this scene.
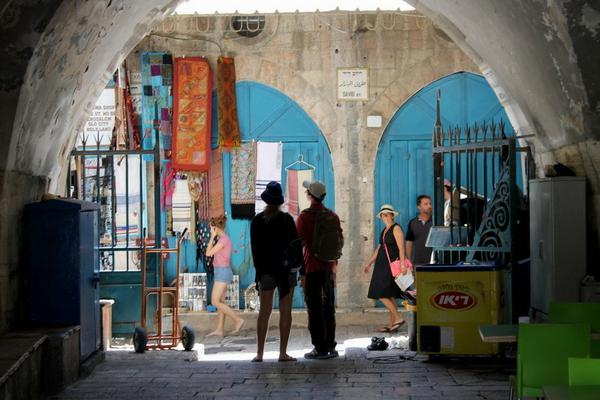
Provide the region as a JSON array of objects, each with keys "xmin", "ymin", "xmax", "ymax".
[{"xmin": 206, "ymin": 215, "xmax": 244, "ymax": 336}]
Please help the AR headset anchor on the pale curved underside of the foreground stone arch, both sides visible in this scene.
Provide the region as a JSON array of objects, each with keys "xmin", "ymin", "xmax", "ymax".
[{"xmin": 4, "ymin": 0, "xmax": 592, "ymax": 187}]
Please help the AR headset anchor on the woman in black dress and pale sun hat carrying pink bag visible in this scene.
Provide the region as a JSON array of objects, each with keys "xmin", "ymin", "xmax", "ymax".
[{"xmin": 363, "ymin": 204, "xmax": 413, "ymax": 332}]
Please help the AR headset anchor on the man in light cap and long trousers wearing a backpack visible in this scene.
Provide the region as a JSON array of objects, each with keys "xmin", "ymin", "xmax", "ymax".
[{"xmin": 296, "ymin": 181, "xmax": 344, "ymax": 360}]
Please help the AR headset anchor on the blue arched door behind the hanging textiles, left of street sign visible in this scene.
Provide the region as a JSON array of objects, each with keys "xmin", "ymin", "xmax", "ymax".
[{"xmin": 212, "ymin": 81, "xmax": 335, "ymax": 308}]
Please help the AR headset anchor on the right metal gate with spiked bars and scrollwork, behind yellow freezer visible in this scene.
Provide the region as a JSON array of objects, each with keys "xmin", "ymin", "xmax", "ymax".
[{"xmin": 427, "ymin": 91, "xmax": 534, "ymax": 321}]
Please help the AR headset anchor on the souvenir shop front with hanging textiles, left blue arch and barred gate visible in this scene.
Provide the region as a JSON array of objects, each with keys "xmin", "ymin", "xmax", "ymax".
[{"xmin": 68, "ymin": 52, "xmax": 334, "ymax": 333}]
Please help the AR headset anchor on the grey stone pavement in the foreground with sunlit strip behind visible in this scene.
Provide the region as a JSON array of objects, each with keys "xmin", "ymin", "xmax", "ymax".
[{"xmin": 51, "ymin": 327, "xmax": 514, "ymax": 400}]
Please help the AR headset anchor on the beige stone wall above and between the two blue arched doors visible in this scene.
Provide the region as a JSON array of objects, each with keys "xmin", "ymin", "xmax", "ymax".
[{"xmin": 128, "ymin": 13, "xmax": 479, "ymax": 308}]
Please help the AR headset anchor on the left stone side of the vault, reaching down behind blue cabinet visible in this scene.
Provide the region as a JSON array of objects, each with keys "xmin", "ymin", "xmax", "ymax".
[{"xmin": 0, "ymin": 0, "xmax": 177, "ymax": 333}]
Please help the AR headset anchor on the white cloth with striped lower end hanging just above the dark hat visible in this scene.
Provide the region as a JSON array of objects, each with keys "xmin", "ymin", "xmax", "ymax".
[{"xmin": 254, "ymin": 142, "xmax": 283, "ymax": 214}]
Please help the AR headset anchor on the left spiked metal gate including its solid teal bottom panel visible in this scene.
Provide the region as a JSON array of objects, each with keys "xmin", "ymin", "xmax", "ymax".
[{"xmin": 66, "ymin": 108, "xmax": 163, "ymax": 333}]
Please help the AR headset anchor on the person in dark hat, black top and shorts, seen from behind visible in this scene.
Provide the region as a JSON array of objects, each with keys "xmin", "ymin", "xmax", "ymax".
[{"xmin": 250, "ymin": 182, "xmax": 302, "ymax": 362}]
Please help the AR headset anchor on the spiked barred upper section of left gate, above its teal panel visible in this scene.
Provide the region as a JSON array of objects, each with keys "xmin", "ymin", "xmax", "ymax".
[{"xmin": 66, "ymin": 108, "xmax": 162, "ymax": 271}]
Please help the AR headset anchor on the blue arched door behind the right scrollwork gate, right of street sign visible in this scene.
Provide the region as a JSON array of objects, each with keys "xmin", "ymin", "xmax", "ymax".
[{"xmin": 374, "ymin": 72, "xmax": 513, "ymax": 236}]
